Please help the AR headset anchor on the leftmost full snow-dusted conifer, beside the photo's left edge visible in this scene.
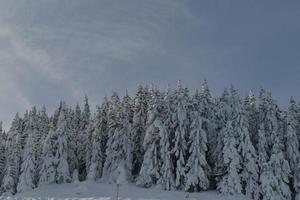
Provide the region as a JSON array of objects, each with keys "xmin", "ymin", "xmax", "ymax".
[{"xmin": 1, "ymin": 113, "xmax": 22, "ymax": 194}]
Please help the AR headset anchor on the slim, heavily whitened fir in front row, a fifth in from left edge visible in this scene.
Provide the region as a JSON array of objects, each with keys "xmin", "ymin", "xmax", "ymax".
[{"xmin": 54, "ymin": 102, "xmax": 71, "ymax": 184}]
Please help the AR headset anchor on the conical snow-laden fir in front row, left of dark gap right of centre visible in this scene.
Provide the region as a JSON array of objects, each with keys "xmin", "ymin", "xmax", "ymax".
[{"xmin": 185, "ymin": 92, "xmax": 209, "ymax": 191}]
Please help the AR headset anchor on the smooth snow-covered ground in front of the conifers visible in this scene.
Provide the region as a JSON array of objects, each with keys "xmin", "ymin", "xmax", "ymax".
[{"xmin": 0, "ymin": 182, "xmax": 247, "ymax": 200}]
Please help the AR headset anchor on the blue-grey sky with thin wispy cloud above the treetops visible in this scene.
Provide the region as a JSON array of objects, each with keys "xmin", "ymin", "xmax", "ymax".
[{"xmin": 0, "ymin": 0, "xmax": 300, "ymax": 127}]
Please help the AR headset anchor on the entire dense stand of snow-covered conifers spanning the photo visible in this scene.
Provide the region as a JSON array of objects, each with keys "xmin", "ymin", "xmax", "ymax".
[{"xmin": 0, "ymin": 81, "xmax": 300, "ymax": 200}]
